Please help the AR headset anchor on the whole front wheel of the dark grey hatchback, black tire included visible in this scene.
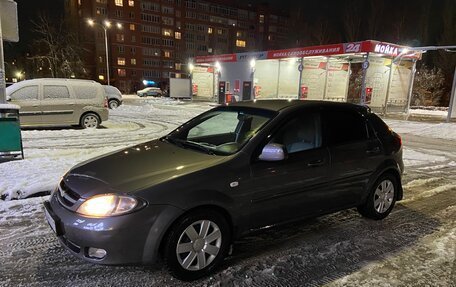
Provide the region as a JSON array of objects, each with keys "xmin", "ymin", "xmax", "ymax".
[{"xmin": 163, "ymin": 210, "xmax": 231, "ymax": 281}]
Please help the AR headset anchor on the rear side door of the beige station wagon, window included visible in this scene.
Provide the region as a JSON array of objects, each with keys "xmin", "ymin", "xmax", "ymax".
[{"xmin": 41, "ymin": 83, "xmax": 75, "ymax": 125}]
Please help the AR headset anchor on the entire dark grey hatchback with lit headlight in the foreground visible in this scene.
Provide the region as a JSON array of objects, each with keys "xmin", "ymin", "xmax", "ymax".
[{"xmin": 45, "ymin": 100, "xmax": 404, "ymax": 280}]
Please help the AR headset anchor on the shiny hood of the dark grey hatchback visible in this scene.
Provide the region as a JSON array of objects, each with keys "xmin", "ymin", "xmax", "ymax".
[{"xmin": 64, "ymin": 140, "xmax": 226, "ymax": 198}]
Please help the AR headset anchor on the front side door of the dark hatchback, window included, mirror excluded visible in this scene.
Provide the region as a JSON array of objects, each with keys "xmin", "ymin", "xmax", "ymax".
[{"xmin": 244, "ymin": 112, "xmax": 329, "ymax": 228}]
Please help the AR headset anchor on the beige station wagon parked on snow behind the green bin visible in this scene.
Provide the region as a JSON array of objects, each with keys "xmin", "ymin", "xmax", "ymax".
[{"xmin": 6, "ymin": 79, "xmax": 108, "ymax": 128}]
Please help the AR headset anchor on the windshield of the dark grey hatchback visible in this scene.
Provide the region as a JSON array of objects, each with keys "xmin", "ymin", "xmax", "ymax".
[{"xmin": 162, "ymin": 107, "xmax": 276, "ymax": 155}]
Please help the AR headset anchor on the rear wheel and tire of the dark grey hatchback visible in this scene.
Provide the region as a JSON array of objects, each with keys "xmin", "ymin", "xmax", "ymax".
[{"xmin": 358, "ymin": 173, "xmax": 399, "ymax": 220}]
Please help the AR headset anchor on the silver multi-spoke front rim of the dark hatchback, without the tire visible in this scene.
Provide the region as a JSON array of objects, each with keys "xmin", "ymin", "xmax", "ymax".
[{"xmin": 176, "ymin": 220, "xmax": 222, "ymax": 271}]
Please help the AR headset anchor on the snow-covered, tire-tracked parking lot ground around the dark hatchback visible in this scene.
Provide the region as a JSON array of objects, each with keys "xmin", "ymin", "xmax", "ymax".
[{"xmin": 0, "ymin": 99, "xmax": 456, "ymax": 286}]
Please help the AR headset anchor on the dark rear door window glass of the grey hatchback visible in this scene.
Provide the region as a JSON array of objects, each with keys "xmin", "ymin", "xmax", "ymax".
[{"xmin": 324, "ymin": 110, "xmax": 368, "ymax": 146}]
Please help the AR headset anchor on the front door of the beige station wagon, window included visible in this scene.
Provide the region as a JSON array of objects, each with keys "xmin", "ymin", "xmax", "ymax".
[{"xmin": 9, "ymin": 85, "xmax": 42, "ymax": 126}]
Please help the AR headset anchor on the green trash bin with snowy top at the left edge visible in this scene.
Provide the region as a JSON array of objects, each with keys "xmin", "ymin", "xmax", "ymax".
[{"xmin": 0, "ymin": 104, "xmax": 24, "ymax": 160}]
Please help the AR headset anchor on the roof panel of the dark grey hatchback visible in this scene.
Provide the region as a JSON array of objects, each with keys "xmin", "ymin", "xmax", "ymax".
[{"xmin": 228, "ymin": 99, "xmax": 370, "ymax": 113}]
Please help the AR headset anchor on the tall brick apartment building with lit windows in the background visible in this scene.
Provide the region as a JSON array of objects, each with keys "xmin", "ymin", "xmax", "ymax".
[{"xmin": 65, "ymin": 0, "xmax": 289, "ymax": 93}]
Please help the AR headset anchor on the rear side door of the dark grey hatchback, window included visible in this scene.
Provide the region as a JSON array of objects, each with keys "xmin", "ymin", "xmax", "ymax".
[{"xmin": 323, "ymin": 108, "xmax": 382, "ymax": 209}]
